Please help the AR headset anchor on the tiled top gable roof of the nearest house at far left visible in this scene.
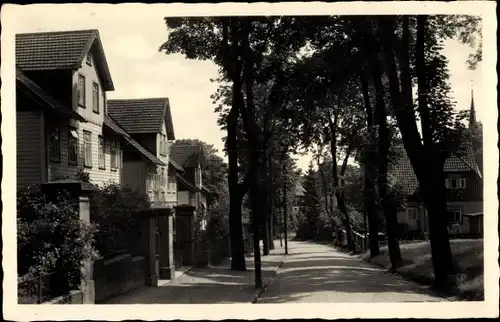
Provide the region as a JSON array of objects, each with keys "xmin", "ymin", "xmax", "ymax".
[{"xmin": 16, "ymin": 29, "xmax": 114, "ymax": 91}]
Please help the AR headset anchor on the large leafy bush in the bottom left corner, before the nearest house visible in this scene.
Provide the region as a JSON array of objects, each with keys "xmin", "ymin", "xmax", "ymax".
[{"xmin": 17, "ymin": 185, "xmax": 97, "ymax": 297}]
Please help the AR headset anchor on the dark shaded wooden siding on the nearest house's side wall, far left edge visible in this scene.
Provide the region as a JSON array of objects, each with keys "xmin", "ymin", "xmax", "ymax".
[{"xmin": 16, "ymin": 110, "xmax": 46, "ymax": 188}]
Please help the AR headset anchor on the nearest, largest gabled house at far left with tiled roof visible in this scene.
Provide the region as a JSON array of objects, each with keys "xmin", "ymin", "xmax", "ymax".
[{"xmin": 16, "ymin": 30, "xmax": 161, "ymax": 187}]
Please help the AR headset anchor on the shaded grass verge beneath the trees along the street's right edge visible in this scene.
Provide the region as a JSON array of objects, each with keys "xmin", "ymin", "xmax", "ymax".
[{"xmin": 358, "ymin": 239, "xmax": 484, "ymax": 301}]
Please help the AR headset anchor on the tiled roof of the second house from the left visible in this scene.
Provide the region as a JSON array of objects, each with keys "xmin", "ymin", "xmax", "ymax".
[{"xmin": 107, "ymin": 97, "xmax": 175, "ymax": 140}]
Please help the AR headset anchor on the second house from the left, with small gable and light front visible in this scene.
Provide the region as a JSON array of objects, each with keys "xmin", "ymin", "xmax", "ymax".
[{"xmin": 108, "ymin": 98, "xmax": 184, "ymax": 206}]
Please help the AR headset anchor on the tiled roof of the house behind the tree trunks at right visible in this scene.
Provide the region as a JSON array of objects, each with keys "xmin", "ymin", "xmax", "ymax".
[{"xmin": 389, "ymin": 145, "xmax": 482, "ymax": 195}]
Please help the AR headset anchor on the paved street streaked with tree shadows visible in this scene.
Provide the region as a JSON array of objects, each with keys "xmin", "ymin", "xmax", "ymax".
[{"xmin": 258, "ymin": 242, "xmax": 445, "ymax": 303}]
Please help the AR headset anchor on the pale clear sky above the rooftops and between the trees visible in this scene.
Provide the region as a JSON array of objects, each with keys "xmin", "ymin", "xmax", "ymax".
[{"xmin": 7, "ymin": 5, "xmax": 487, "ymax": 170}]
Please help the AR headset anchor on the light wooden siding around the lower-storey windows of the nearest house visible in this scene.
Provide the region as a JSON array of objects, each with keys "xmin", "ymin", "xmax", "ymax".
[{"xmin": 48, "ymin": 121, "xmax": 120, "ymax": 185}]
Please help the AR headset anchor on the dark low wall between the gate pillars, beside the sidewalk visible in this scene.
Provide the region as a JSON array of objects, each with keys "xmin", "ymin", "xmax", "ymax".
[{"xmin": 94, "ymin": 254, "xmax": 147, "ymax": 303}]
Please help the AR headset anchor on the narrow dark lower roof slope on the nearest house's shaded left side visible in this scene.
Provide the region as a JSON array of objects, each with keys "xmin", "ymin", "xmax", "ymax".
[{"xmin": 16, "ymin": 68, "xmax": 86, "ymax": 122}]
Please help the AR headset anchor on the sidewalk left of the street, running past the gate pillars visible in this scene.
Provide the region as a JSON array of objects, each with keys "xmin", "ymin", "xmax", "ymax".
[{"xmin": 103, "ymin": 240, "xmax": 285, "ymax": 304}]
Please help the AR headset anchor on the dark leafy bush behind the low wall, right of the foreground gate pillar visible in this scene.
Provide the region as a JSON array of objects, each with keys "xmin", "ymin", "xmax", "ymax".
[{"xmin": 90, "ymin": 183, "xmax": 151, "ymax": 257}]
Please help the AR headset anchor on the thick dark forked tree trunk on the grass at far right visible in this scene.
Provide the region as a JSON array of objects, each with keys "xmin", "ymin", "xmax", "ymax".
[{"xmin": 377, "ymin": 16, "xmax": 463, "ymax": 287}]
